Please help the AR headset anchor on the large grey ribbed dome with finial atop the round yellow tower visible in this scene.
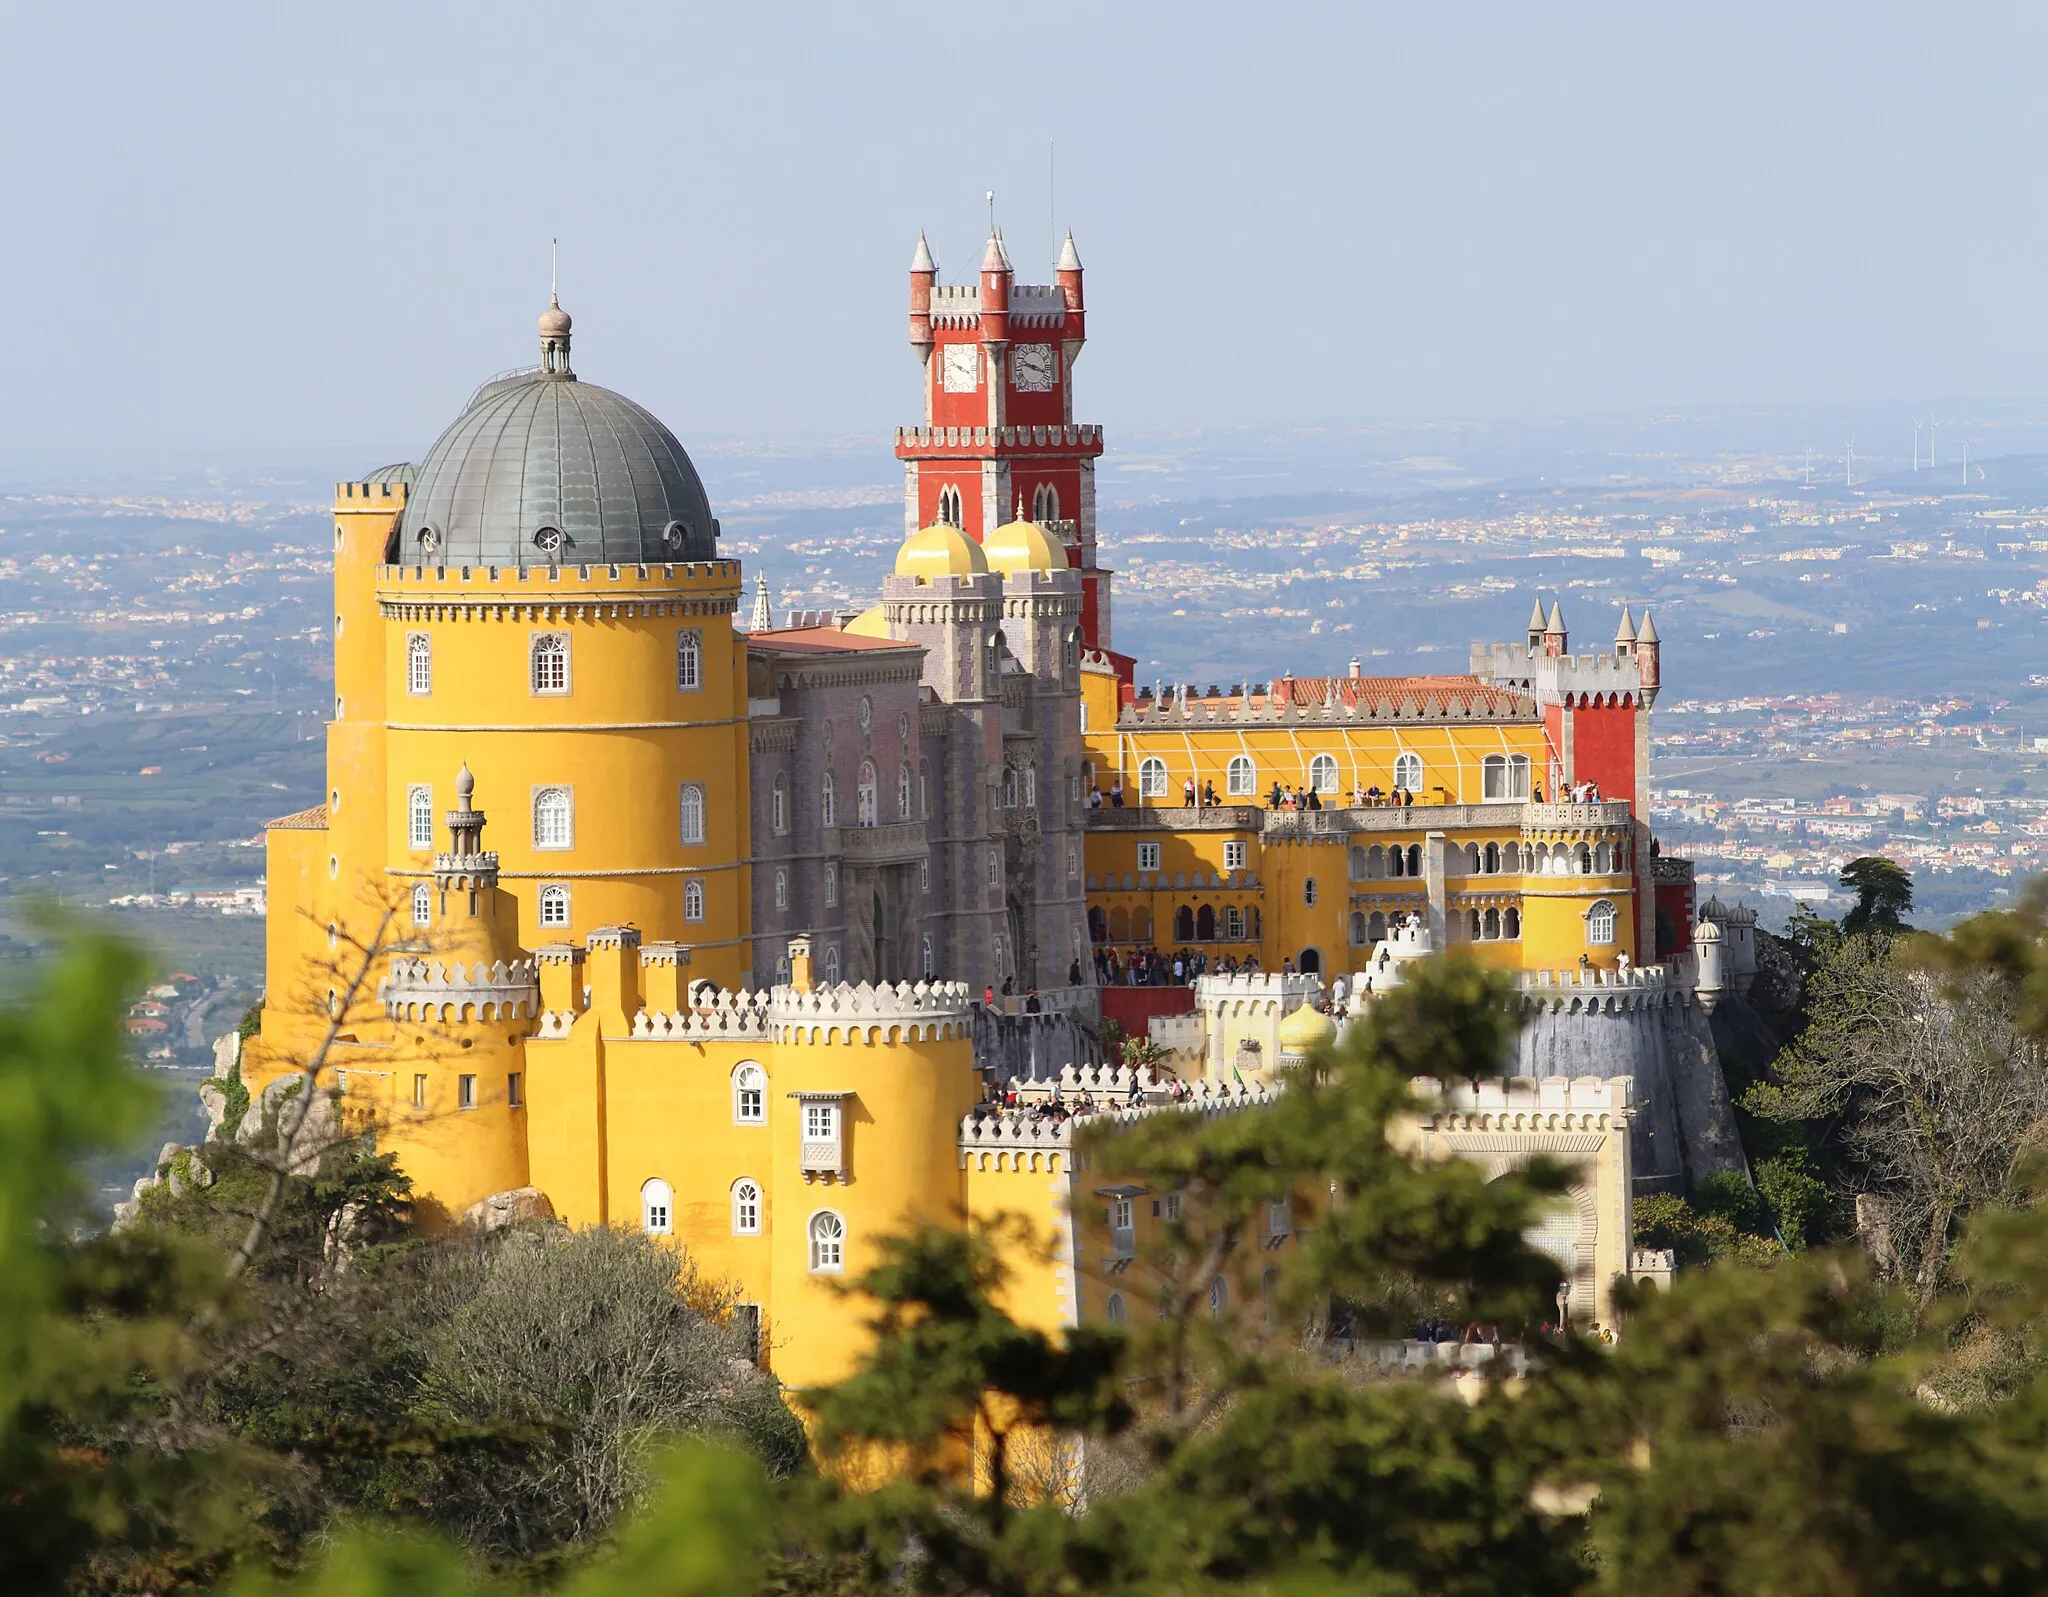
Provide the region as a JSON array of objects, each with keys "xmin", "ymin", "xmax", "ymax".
[{"xmin": 387, "ymin": 364, "xmax": 719, "ymax": 565}]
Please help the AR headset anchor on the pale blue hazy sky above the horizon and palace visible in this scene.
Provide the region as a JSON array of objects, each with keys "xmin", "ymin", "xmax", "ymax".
[{"xmin": 0, "ymin": 0, "xmax": 2048, "ymax": 465}]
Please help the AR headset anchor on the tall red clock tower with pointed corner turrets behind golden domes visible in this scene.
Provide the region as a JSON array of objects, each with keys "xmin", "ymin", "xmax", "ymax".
[{"xmin": 897, "ymin": 221, "xmax": 1110, "ymax": 651}]
